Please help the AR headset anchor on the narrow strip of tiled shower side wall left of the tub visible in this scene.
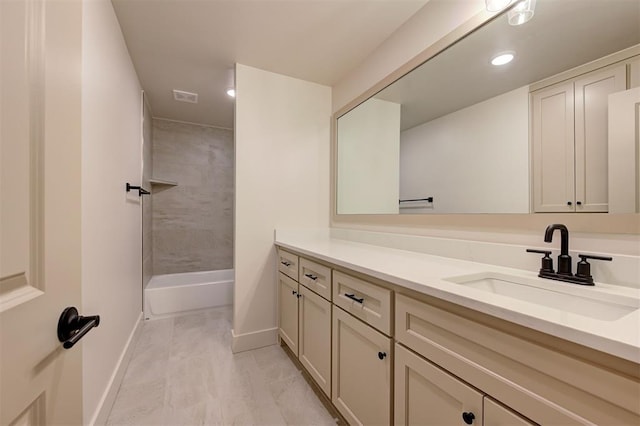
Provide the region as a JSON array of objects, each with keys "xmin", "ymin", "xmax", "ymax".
[{"xmin": 142, "ymin": 98, "xmax": 153, "ymax": 287}]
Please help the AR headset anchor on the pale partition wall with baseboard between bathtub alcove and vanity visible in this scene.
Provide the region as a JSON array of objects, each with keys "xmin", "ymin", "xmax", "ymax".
[{"xmin": 233, "ymin": 64, "xmax": 331, "ymax": 351}]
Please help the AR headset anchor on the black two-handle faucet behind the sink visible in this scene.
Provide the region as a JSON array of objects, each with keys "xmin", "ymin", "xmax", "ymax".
[{"xmin": 527, "ymin": 223, "xmax": 613, "ymax": 285}]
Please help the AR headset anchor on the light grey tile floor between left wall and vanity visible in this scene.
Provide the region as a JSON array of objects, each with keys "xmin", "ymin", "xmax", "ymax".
[{"xmin": 107, "ymin": 307, "xmax": 336, "ymax": 426}]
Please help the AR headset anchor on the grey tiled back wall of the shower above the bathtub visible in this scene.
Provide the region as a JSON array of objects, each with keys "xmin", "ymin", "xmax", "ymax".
[{"xmin": 152, "ymin": 119, "xmax": 234, "ymax": 275}]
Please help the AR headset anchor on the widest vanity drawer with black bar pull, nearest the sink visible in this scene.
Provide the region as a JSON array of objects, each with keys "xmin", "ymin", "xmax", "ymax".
[{"xmin": 333, "ymin": 271, "xmax": 391, "ymax": 336}]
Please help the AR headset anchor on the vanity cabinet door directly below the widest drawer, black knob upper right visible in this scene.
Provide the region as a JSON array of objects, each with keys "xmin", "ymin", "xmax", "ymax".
[{"xmin": 331, "ymin": 306, "xmax": 392, "ymax": 425}]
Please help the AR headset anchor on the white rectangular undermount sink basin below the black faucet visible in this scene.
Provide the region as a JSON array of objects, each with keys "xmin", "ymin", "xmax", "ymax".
[{"xmin": 444, "ymin": 272, "xmax": 640, "ymax": 321}]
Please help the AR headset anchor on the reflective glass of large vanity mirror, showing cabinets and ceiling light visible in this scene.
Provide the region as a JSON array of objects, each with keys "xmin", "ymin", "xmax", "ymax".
[{"xmin": 336, "ymin": 0, "xmax": 640, "ymax": 214}]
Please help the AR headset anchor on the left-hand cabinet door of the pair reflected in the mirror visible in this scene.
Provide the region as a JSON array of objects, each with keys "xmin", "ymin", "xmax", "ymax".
[{"xmin": 531, "ymin": 82, "xmax": 576, "ymax": 213}]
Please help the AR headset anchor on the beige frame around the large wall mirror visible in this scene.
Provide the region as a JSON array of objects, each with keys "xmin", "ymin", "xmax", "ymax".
[{"xmin": 330, "ymin": 5, "xmax": 640, "ymax": 235}]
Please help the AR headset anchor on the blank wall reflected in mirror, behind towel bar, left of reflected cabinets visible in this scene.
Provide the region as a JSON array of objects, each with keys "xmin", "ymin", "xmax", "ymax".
[{"xmin": 400, "ymin": 86, "xmax": 529, "ymax": 214}]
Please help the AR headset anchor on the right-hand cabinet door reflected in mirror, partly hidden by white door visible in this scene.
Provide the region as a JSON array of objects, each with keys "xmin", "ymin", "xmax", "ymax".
[{"xmin": 575, "ymin": 64, "xmax": 627, "ymax": 213}]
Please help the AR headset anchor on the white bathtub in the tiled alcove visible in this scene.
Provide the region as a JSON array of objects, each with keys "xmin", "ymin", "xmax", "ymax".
[{"xmin": 144, "ymin": 269, "xmax": 234, "ymax": 319}]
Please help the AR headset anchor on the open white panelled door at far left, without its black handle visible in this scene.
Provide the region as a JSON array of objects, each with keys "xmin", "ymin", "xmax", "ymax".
[{"xmin": 0, "ymin": 0, "xmax": 84, "ymax": 425}]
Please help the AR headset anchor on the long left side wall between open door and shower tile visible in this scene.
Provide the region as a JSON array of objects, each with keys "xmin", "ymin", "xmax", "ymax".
[{"xmin": 81, "ymin": 0, "xmax": 142, "ymax": 424}]
